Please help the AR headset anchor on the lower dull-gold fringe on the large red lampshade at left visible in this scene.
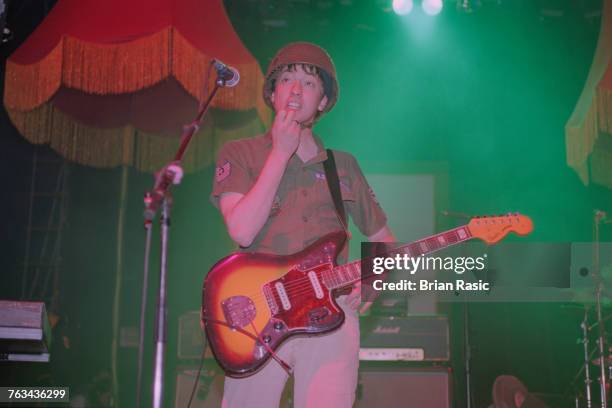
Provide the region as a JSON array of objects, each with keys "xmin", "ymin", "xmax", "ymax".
[{"xmin": 8, "ymin": 103, "xmax": 263, "ymax": 173}]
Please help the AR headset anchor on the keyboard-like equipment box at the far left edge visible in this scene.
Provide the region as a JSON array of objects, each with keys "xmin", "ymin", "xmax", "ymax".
[{"xmin": 0, "ymin": 300, "xmax": 51, "ymax": 362}]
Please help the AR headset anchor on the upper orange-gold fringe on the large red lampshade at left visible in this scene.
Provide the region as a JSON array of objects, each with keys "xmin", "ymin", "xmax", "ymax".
[{"xmin": 4, "ymin": 27, "xmax": 271, "ymax": 123}]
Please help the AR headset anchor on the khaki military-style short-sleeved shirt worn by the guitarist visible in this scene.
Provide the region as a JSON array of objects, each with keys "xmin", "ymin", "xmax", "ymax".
[{"xmin": 211, "ymin": 133, "xmax": 387, "ymax": 262}]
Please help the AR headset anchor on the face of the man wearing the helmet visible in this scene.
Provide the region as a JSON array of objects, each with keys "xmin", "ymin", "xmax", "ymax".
[{"xmin": 270, "ymin": 64, "xmax": 327, "ymax": 124}]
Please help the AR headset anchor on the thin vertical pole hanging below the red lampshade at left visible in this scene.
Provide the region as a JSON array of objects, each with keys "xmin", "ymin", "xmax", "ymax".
[{"xmin": 111, "ymin": 165, "xmax": 128, "ymax": 406}]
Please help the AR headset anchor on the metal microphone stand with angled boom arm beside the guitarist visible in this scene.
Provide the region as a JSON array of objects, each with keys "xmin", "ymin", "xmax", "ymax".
[{"xmin": 136, "ymin": 67, "xmax": 229, "ymax": 408}]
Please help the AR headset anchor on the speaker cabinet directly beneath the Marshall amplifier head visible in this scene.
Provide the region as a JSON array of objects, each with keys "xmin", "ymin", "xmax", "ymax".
[{"xmin": 355, "ymin": 367, "xmax": 452, "ymax": 408}]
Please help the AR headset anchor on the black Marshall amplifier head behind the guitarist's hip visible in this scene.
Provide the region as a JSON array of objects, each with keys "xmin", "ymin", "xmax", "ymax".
[{"xmin": 359, "ymin": 316, "xmax": 450, "ymax": 361}]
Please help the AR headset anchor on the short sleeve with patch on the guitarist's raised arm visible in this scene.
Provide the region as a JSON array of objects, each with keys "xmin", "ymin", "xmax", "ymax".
[{"xmin": 210, "ymin": 142, "xmax": 252, "ymax": 208}]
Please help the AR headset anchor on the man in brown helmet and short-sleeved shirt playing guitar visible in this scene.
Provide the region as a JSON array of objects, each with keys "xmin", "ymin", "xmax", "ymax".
[{"xmin": 212, "ymin": 43, "xmax": 394, "ymax": 408}]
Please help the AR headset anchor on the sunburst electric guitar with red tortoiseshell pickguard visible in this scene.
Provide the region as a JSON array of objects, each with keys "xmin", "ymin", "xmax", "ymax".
[{"xmin": 201, "ymin": 214, "xmax": 533, "ymax": 377}]
